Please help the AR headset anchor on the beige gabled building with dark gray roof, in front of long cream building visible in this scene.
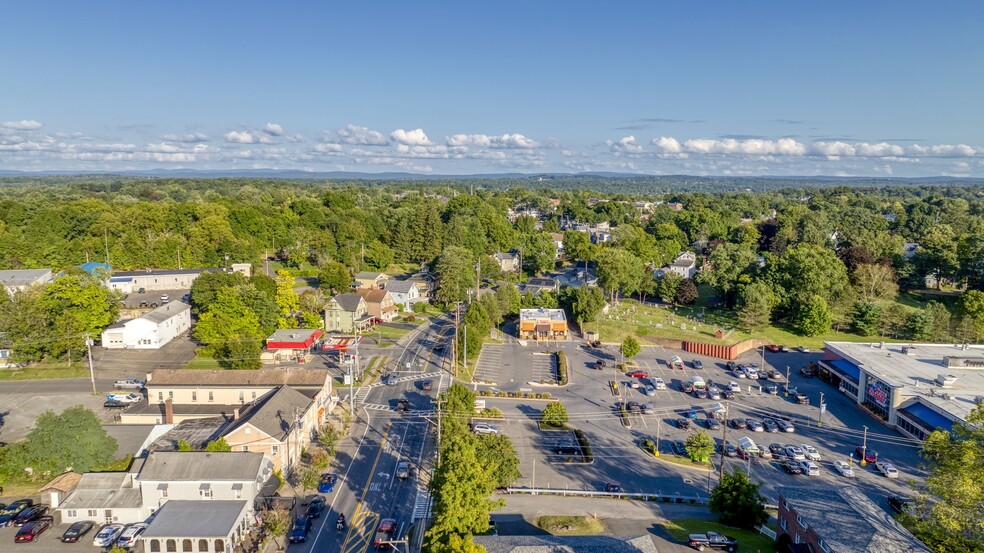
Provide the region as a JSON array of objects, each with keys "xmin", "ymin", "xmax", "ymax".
[{"xmin": 222, "ymin": 386, "xmax": 324, "ymax": 470}]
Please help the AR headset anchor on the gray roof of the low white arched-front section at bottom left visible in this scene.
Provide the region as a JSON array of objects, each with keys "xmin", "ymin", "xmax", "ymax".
[{"xmin": 141, "ymin": 499, "xmax": 249, "ymax": 539}]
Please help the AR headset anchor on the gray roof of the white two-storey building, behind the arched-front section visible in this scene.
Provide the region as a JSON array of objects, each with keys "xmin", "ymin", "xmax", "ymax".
[{"xmin": 140, "ymin": 451, "xmax": 264, "ymax": 482}]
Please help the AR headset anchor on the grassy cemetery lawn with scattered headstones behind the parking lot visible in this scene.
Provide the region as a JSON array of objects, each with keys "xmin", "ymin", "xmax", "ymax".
[{"xmin": 583, "ymin": 299, "xmax": 916, "ymax": 349}]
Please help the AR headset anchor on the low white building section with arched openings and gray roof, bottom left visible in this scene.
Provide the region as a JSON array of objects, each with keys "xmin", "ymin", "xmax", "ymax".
[{"xmin": 140, "ymin": 499, "xmax": 254, "ymax": 553}]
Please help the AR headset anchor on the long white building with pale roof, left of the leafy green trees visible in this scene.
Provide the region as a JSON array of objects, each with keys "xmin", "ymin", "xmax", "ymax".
[{"xmin": 102, "ymin": 301, "xmax": 191, "ymax": 349}]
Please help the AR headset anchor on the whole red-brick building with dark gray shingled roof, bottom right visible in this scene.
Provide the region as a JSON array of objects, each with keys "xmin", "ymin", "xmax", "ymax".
[{"xmin": 776, "ymin": 486, "xmax": 930, "ymax": 553}]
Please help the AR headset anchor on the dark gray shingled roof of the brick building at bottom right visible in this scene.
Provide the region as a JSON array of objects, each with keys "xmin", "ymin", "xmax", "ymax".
[{"xmin": 777, "ymin": 486, "xmax": 930, "ymax": 553}]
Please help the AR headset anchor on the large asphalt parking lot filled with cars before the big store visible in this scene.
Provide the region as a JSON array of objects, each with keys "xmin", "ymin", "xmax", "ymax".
[{"xmin": 479, "ymin": 343, "xmax": 924, "ymax": 505}]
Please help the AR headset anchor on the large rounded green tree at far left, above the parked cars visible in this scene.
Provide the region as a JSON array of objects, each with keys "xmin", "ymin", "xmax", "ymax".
[{"xmin": 17, "ymin": 405, "xmax": 117, "ymax": 475}]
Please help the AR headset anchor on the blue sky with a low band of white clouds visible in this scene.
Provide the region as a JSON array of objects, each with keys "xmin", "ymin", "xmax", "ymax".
[{"xmin": 0, "ymin": 0, "xmax": 984, "ymax": 177}]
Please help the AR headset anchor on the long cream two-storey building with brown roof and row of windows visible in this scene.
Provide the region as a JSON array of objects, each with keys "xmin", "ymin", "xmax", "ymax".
[{"xmin": 120, "ymin": 368, "xmax": 337, "ymax": 424}]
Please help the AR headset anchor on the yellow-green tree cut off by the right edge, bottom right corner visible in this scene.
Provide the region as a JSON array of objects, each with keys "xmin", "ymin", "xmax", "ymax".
[{"xmin": 922, "ymin": 405, "xmax": 984, "ymax": 546}]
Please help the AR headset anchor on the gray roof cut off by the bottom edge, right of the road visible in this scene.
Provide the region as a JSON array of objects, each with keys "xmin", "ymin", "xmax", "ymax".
[{"xmin": 474, "ymin": 536, "xmax": 657, "ymax": 553}]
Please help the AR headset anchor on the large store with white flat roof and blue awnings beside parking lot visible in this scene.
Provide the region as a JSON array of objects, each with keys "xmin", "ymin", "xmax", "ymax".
[{"xmin": 820, "ymin": 342, "xmax": 984, "ymax": 440}]
